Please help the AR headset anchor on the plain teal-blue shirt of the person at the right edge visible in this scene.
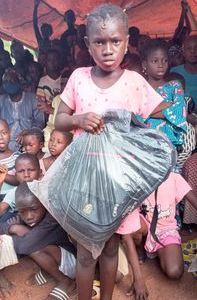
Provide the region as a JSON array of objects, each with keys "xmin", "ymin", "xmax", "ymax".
[{"xmin": 170, "ymin": 65, "xmax": 197, "ymax": 110}]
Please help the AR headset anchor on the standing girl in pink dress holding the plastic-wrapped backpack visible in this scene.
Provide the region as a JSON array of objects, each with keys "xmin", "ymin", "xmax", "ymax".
[{"xmin": 55, "ymin": 4, "xmax": 167, "ymax": 300}]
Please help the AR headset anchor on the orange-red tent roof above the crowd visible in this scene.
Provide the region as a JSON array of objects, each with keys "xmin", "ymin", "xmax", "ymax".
[{"xmin": 0, "ymin": 0, "xmax": 197, "ymax": 48}]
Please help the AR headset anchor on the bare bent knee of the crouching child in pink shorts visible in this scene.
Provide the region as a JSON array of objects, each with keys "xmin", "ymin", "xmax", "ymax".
[{"xmin": 158, "ymin": 244, "xmax": 184, "ymax": 279}]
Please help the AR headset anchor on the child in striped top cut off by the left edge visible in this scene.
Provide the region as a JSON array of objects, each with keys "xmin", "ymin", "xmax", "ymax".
[{"xmin": 0, "ymin": 119, "xmax": 19, "ymax": 201}]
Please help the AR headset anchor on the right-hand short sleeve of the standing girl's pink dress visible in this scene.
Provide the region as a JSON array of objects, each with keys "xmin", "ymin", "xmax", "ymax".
[{"xmin": 136, "ymin": 74, "xmax": 163, "ymax": 119}]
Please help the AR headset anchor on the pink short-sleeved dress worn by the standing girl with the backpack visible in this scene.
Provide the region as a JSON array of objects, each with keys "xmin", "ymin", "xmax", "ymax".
[{"xmin": 60, "ymin": 67, "xmax": 163, "ymax": 234}]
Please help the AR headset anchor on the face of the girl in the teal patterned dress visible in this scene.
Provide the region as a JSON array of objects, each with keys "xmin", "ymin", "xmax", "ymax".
[{"xmin": 143, "ymin": 49, "xmax": 168, "ymax": 80}]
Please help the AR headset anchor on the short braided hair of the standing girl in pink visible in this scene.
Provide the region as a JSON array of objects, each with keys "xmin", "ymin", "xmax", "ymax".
[{"xmin": 86, "ymin": 4, "xmax": 128, "ymax": 36}]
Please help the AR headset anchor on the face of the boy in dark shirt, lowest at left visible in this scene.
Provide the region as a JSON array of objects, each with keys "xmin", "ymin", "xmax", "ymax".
[{"xmin": 16, "ymin": 195, "xmax": 46, "ymax": 227}]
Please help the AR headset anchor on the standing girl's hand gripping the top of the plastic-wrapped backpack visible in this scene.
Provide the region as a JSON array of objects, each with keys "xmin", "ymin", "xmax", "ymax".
[{"xmin": 74, "ymin": 112, "xmax": 104, "ymax": 134}]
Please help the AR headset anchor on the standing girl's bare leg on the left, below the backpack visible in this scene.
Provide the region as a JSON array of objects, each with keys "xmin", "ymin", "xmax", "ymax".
[{"xmin": 77, "ymin": 244, "xmax": 97, "ymax": 300}]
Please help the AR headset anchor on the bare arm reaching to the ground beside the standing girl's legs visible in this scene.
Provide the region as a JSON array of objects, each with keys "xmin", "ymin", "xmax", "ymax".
[{"xmin": 123, "ymin": 234, "xmax": 148, "ymax": 300}]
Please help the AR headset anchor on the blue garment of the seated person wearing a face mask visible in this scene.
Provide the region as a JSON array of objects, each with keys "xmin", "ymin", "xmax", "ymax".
[{"xmin": 0, "ymin": 92, "xmax": 45, "ymax": 151}]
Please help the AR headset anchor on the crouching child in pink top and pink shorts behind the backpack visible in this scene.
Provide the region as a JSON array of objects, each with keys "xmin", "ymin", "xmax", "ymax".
[{"xmin": 123, "ymin": 172, "xmax": 197, "ymax": 299}]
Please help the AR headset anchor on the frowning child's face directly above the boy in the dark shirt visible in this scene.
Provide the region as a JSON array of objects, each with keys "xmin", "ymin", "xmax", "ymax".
[{"xmin": 15, "ymin": 159, "xmax": 41, "ymax": 183}]
